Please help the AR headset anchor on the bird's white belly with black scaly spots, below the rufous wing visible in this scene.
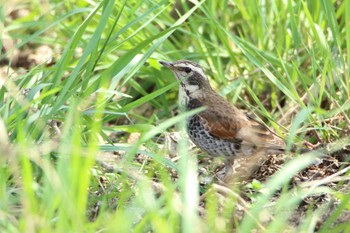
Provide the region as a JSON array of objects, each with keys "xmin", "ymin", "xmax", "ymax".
[{"xmin": 187, "ymin": 116, "xmax": 239, "ymax": 156}]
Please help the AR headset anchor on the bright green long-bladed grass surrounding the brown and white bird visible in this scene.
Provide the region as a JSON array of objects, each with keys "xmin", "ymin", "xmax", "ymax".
[{"xmin": 0, "ymin": 0, "xmax": 350, "ymax": 232}]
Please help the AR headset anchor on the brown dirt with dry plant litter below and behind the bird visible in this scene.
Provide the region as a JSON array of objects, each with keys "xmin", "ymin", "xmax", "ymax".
[{"xmin": 95, "ymin": 134, "xmax": 350, "ymax": 231}]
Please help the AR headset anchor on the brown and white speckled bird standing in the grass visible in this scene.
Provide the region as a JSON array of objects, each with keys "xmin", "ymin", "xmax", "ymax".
[{"xmin": 160, "ymin": 60, "xmax": 292, "ymax": 180}]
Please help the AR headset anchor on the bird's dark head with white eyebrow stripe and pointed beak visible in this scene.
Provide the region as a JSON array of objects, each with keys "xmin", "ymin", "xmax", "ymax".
[{"xmin": 159, "ymin": 60, "xmax": 212, "ymax": 98}]
